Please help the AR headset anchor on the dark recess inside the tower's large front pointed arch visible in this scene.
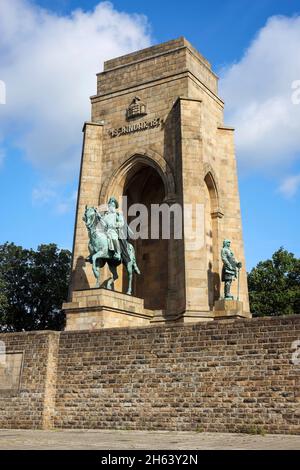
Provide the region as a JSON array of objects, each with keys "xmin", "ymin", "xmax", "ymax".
[{"xmin": 123, "ymin": 161, "xmax": 169, "ymax": 310}]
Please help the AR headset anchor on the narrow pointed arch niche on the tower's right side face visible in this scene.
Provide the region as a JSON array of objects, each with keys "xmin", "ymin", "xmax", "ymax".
[{"xmin": 204, "ymin": 171, "xmax": 222, "ymax": 310}]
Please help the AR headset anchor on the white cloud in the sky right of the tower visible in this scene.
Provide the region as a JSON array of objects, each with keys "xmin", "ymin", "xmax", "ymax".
[{"xmin": 220, "ymin": 16, "xmax": 300, "ymax": 175}]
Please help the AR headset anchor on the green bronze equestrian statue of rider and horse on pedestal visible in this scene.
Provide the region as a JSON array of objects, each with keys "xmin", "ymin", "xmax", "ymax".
[{"xmin": 83, "ymin": 196, "xmax": 140, "ymax": 294}]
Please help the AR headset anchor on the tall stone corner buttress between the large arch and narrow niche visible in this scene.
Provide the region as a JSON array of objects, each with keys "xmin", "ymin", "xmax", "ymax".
[{"xmin": 180, "ymin": 98, "xmax": 211, "ymax": 321}]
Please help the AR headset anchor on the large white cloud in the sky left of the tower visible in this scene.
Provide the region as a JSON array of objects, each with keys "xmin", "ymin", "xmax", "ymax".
[{"xmin": 0, "ymin": 0, "xmax": 150, "ymax": 181}]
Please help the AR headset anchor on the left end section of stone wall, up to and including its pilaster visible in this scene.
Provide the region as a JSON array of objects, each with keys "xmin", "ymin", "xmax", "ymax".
[{"xmin": 0, "ymin": 331, "xmax": 59, "ymax": 429}]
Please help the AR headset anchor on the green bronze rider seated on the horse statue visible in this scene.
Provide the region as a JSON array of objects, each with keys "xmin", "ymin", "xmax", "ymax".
[{"xmin": 97, "ymin": 196, "xmax": 129, "ymax": 261}]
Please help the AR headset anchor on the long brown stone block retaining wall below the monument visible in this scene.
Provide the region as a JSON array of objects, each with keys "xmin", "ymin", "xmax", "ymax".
[{"xmin": 0, "ymin": 316, "xmax": 300, "ymax": 434}]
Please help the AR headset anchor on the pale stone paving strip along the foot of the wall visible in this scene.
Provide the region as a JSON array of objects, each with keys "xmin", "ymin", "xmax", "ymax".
[{"xmin": 0, "ymin": 429, "xmax": 300, "ymax": 450}]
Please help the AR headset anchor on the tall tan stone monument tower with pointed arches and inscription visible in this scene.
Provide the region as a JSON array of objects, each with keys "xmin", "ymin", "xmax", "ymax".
[{"xmin": 64, "ymin": 37, "xmax": 250, "ymax": 330}]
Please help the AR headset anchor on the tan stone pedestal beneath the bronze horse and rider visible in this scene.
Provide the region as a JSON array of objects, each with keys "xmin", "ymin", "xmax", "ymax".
[{"xmin": 63, "ymin": 288, "xmax": 153, "ymax": 331}]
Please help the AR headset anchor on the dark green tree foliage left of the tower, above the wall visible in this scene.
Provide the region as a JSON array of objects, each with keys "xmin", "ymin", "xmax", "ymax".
[{"xmin": 0, "ymin": 243, "xmax": 71, "ymax": 331}]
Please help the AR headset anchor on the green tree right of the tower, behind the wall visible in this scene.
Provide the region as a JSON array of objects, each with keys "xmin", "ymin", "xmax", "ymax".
[{"xmin": 248, "ymin": 247, "xmax": 300, "ymax": 316}]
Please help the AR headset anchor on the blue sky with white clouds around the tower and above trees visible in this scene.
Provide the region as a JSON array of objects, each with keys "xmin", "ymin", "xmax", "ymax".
[{"xmin": 0, "ymin": 0, "xmax": 300, "ymax": 269}]
